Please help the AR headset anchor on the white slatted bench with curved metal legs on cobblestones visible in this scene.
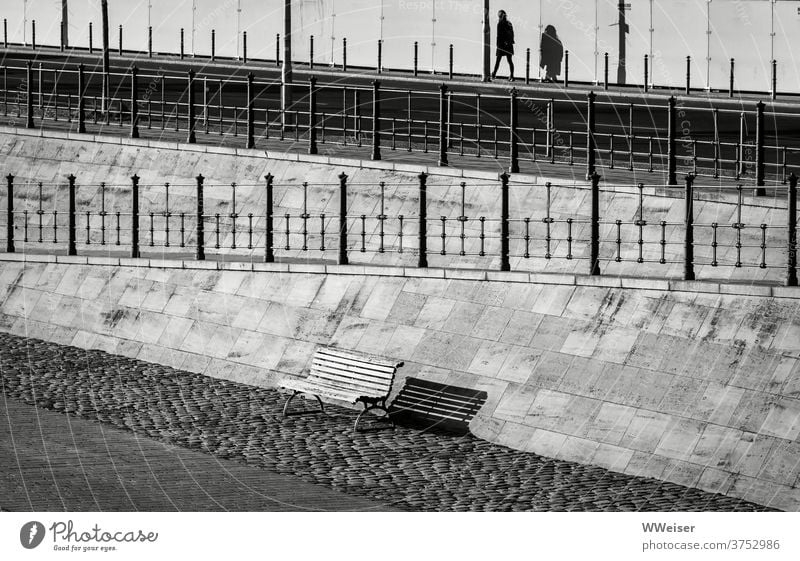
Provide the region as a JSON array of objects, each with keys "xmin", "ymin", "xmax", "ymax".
[{"xmin": 281, "ymin": 347, "xmax": 403, "ymax": 431}]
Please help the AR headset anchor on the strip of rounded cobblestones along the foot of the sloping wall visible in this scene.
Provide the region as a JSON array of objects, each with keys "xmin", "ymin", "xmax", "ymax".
[{"xmin": 0, "ymin": 334, "xmax": 767, "ymax": 511}]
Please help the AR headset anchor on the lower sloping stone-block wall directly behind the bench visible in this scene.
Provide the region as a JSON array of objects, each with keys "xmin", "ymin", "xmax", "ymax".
[{"xmin": 0, "ymin": 255, "xmax": 800, "ymax": 510}]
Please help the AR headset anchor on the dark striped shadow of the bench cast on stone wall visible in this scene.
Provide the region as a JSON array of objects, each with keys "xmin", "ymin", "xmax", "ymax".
[{"xmin": 389, "ymin": 378, "xmax": 488, "ymax": 434}]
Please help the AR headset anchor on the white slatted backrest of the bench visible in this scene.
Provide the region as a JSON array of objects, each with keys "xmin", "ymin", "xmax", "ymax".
[{"xmin": 308, "ymin": 347, "xmax": 403, "ymax": 398}]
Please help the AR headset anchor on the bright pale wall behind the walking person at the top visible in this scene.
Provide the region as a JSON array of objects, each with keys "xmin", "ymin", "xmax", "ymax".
[{"xmin": 0, "ymin": 0, "xmax": 800, "ymax": 92}]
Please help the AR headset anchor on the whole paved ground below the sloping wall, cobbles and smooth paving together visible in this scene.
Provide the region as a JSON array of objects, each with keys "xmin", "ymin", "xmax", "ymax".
[{"xmin": 0, "ymin": 334, "xmax": 766, "ymax": 511}]
